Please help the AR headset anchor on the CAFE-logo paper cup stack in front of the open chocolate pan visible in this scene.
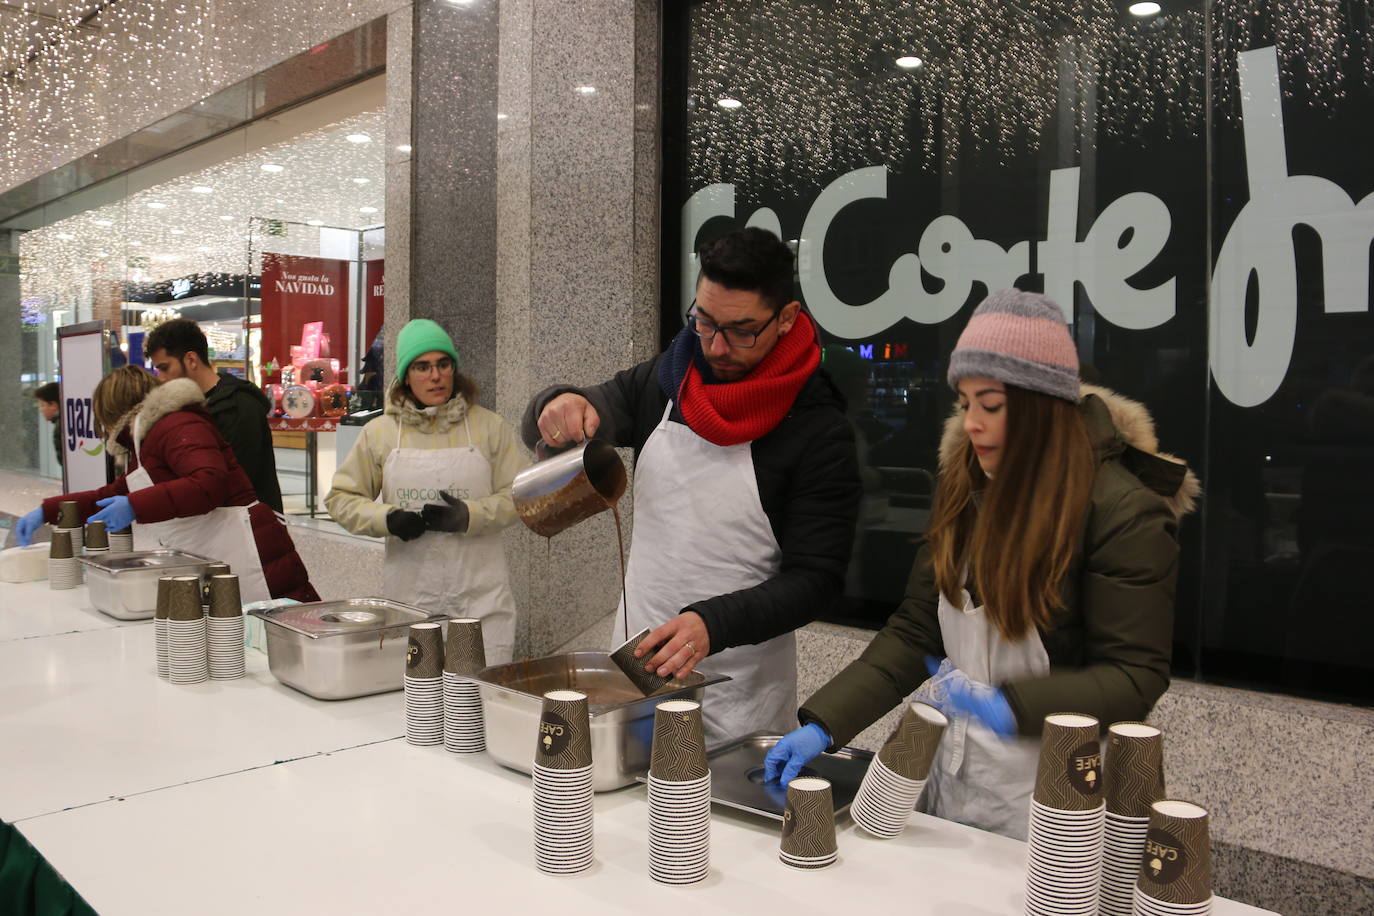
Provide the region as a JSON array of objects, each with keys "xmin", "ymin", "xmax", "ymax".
[{"xmin": 533, "ymin": 691, "xmax": 595, "ymax": 875}]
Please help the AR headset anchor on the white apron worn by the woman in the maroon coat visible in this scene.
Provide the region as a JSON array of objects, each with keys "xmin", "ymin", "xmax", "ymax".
[{"xmin": 124, "ymin": 417, "xmax": 272, "ymax": 604}]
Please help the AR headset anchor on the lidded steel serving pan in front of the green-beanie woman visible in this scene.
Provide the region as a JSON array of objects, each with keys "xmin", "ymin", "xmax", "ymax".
[{"xmin": 249, "ymin": 597, "xmax": 447, "ymax": 700}]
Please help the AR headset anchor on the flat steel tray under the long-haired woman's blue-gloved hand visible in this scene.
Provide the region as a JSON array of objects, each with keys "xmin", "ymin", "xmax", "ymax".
[{"xmin": 638, "ymin": 732, "xmax": 872, "ymax": 821}]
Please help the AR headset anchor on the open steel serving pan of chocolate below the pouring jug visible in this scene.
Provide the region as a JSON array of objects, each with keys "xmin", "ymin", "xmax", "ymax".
[{"xmin": 473, "ymin": 652, "xmax": 730, "ymax": 792}]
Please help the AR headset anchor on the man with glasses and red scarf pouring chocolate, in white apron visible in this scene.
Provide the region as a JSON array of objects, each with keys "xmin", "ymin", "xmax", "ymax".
[{"xmin": 522, "ymin": 228, "xmax": 860, "ymax": 743}]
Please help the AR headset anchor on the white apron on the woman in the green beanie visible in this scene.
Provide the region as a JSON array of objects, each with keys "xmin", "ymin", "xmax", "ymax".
[{"xmin": 382, "ymin": 417, "xmax": 515, "ymax": 665}]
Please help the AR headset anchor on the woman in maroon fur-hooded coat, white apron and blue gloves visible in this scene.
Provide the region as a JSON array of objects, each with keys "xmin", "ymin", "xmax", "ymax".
[{"xmin": 15, "ymin": 365, "xmax": 320, "ymax": 603}]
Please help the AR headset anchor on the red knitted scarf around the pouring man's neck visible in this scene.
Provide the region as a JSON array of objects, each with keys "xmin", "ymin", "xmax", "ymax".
[{"xmin": 677, "ymin": 312, "xmax": 820, "ymax": 445}]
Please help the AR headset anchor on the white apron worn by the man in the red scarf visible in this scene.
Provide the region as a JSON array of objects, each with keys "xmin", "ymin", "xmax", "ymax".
[{"xmin": 613, "ymin": 401, "xmax": 797, "ymax": 744}]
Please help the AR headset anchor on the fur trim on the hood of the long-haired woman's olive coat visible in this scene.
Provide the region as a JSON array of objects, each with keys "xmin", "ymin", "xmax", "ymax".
[{"xmin": 940, "ymin": 385, "xmax": 1202, "ymax": 518}]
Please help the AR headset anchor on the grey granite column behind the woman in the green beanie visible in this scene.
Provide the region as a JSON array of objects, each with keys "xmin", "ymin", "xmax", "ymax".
[{"xmin": 386, "ymin": 0, "xmax": 660, "ymax": 656}]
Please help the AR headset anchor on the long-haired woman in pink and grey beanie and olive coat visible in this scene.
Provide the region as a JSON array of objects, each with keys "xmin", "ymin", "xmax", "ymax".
[{"xmin": 765, "ymin": 290, "xmax": 1200, "ymax": 838}]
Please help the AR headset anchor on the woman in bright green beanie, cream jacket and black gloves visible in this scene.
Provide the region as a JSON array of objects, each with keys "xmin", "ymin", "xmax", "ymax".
[{"xmin": 324, "ymin": 319, "xmax": 528, "ymax": 665}]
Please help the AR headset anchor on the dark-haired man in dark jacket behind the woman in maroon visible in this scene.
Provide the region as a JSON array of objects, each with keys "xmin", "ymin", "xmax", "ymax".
[{"xmin": 143, "ymin": 319, "xmax": 282, "ymax": 512}]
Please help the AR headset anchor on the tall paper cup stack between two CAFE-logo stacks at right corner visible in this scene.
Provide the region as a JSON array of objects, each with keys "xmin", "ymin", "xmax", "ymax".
[{"xmin": 1098, "ymin": 722, "xmax": 1164, "ymax": 916}]
